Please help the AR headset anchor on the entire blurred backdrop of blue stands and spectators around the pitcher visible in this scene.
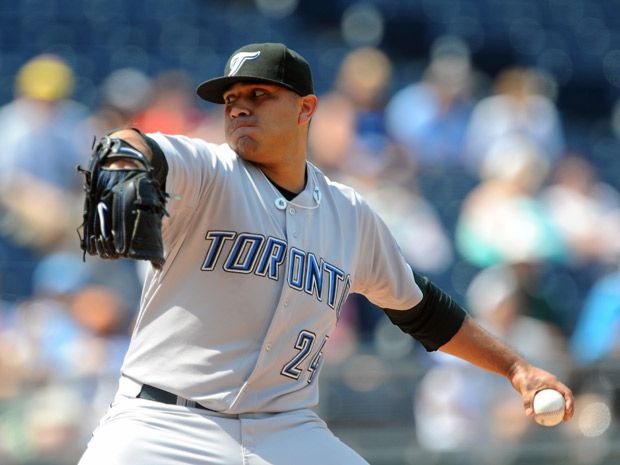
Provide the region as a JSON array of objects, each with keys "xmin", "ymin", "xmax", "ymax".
[{"xmin": 0, "ymin": 0, "xmax": 620, "ymax": 465}]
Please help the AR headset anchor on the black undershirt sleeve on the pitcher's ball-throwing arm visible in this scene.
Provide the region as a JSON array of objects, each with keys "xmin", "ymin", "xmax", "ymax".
[{"xmin": 383, "ymin": 271, "xmax": 467, "ymax": 352}]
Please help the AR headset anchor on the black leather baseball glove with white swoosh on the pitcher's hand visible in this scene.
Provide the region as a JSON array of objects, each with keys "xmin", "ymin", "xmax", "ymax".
[{"xmin": 77, "ymin": 136, "xmax": 168, "ymax": 268}]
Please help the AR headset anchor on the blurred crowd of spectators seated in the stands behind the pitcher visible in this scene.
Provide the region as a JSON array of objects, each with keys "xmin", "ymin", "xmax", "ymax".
[{"xmin": 0, "ymin": 36, "xmax": 620, "ymax": 465}]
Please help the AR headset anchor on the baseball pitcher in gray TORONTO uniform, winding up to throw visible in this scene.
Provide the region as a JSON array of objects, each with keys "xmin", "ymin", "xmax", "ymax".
[{"xmin": 80, "ymin": 43, "xmax": 573, "ymax": 465}]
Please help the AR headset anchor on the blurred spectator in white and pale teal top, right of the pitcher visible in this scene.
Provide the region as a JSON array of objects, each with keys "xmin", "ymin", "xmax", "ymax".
[{"xmin": 456, "ymin": 137, "xmax": 565, "ymax": 267}]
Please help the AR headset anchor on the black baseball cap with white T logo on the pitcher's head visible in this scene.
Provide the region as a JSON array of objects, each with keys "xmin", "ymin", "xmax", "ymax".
[{"xmin": 196, "ymin": 43, "xmax": 314, "ymax": 103}]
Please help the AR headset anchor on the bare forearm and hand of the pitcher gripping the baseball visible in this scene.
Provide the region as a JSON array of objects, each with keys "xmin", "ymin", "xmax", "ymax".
[{"xmin": 439, "ymin": 317, "xmax": 574, "ymax": 421}]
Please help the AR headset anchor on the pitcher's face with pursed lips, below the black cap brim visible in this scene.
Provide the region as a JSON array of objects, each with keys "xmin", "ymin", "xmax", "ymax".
[{"xmin": 224, "ymin": 83, "xmax": 304, "ymax": 163}]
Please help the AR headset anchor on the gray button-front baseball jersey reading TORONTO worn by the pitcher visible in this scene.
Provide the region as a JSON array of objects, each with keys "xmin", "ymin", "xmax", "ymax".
[{"xmin": 122, "ymin": 133, "xmax": 422, "ymax": 413}]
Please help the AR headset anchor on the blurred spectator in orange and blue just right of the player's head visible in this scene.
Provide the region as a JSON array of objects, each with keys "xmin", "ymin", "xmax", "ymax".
[{"xmin": 310, "ymin": 47, "xmax": 407, "ymax": 180}]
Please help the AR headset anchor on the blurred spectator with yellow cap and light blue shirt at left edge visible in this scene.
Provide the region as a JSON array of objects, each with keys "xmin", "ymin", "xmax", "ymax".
[{"xmin": 0, "ymin": 54, "xmax": 92, "ymax": 300}]
